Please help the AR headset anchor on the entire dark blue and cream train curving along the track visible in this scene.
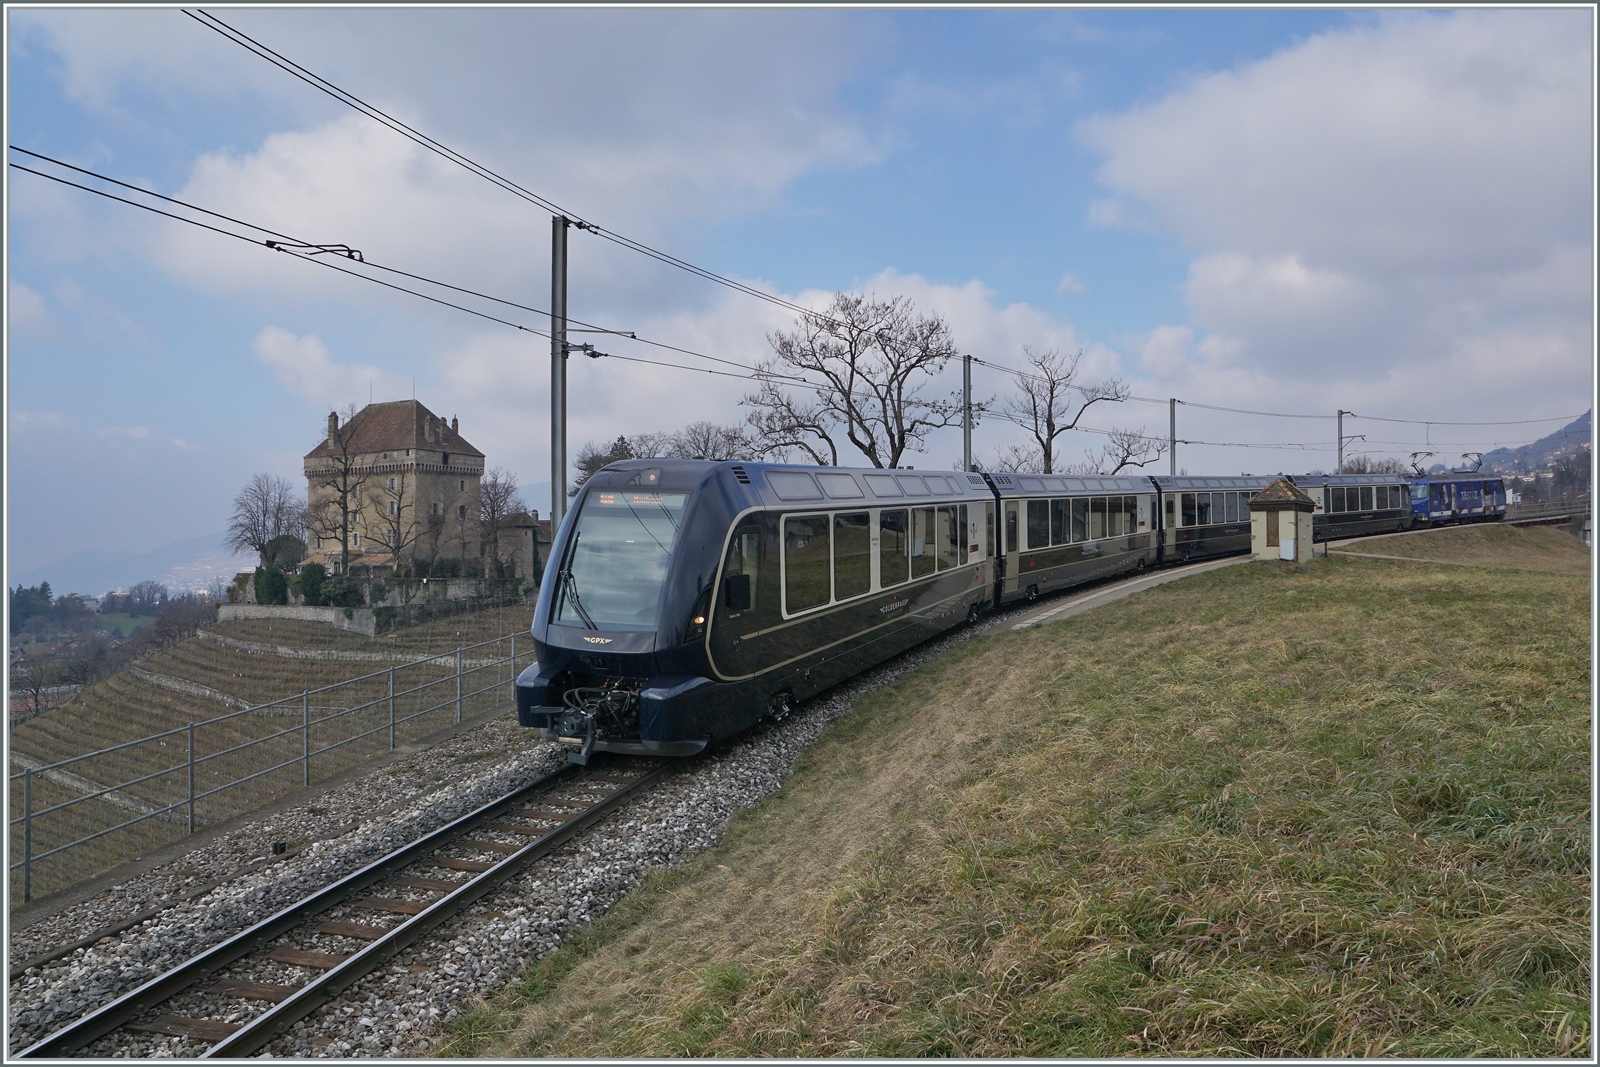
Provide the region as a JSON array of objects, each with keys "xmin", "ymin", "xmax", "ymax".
[{"xmin": 517, "ymin": 459, "xmax": 1506, "ymax": 763}]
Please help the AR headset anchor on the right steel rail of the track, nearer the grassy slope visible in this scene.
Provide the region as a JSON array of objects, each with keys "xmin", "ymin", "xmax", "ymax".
[{"xmin": 200, "ymin": 761, "xmax": 677, "ymax": 1059}]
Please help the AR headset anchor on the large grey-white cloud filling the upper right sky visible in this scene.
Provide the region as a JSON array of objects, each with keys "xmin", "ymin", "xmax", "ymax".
[{"xmin": 1080, "ymin": 11, "xmax": 1594, "ymax": 435}]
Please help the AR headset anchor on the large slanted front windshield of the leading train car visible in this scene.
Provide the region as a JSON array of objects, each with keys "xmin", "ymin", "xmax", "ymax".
[{"xmin": 554, "ymin": 488, "xmax": 690, "ymax": 630}]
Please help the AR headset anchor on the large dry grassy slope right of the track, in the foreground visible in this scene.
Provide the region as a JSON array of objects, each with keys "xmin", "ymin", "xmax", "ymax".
[{"xmin": 451, "ymin": 550, "xmax": 1590, "ymax": 1056}]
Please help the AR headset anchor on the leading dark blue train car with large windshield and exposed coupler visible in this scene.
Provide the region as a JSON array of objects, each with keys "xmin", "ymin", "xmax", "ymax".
[{"xmin": 517, "ymin": 459, "xmax": 995, "ymax": 761}]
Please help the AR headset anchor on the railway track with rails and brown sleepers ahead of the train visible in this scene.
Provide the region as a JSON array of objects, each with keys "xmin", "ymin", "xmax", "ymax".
[{"xmin": 14, "ymin": 758, "xmax": 682, "ymax": 1059}]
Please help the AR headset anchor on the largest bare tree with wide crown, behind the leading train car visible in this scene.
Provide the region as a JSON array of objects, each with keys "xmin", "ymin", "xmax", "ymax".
[{"xmin": 741, "ymin": 293, "xmax": 987, "ymax": 467}]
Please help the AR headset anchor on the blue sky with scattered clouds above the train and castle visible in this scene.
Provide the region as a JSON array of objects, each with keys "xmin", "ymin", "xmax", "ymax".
[{"xmin": 6, "ymin": 6, "xmax": 1595, "ymax": 585}]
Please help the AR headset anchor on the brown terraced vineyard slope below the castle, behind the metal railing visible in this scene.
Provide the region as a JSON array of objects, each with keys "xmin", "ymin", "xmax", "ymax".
[{"xmin": 10, "ymin": 608, "xmax": 533, "ymax": 901}]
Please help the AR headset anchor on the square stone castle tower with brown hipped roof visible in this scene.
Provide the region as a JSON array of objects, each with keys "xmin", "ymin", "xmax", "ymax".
[{"xmin": 304, "ymin": 400, "xmax": 483, "ymax": 573}]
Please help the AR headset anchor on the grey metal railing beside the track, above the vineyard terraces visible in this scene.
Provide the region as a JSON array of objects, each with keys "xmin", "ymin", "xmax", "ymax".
[{"xmin": 8, "ymin": 633, "xmax": 533, "ymax": 902}]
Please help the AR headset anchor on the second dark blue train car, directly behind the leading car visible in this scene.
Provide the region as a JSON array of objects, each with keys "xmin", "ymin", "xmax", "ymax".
[{"xmin": 982, "ymin": 474, "xmax": 1160, "ymax": 606}]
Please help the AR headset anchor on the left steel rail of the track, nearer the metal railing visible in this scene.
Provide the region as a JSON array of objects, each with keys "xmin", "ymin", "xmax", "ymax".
[{"xmin": 13, "ymin": 763, "xmax": 601, "ymax": 1059}]
